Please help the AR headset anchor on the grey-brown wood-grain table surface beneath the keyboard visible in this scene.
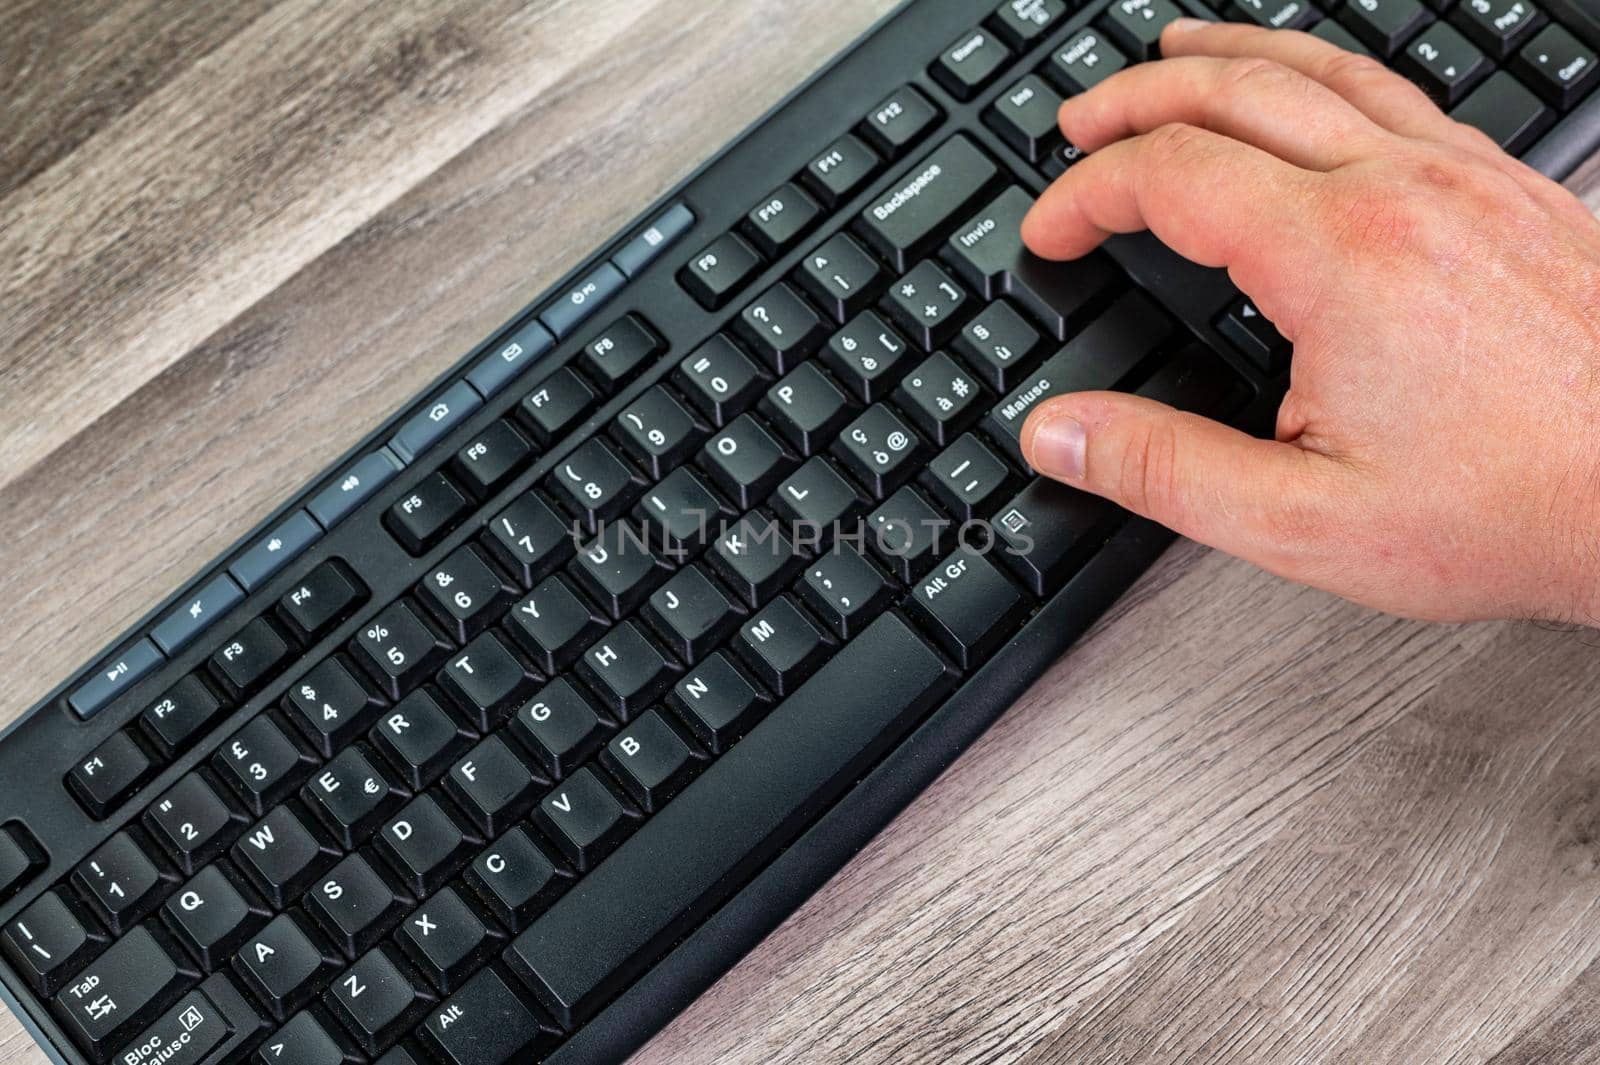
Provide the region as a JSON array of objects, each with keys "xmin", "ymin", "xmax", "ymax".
[{"xmin": 0, "ymin": 0, "xmax": 1600, "ymax": 1065}]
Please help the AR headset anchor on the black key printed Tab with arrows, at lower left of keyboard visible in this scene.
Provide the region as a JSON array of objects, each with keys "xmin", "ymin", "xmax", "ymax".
[{"xmin": 56, "ymin": 927, "xmax": 194, "ymax": 1059}]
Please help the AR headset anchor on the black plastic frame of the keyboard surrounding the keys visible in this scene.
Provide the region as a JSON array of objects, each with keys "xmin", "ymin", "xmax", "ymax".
[{"xmin": 0, "ymin": 0, "xmax": 1600, "ymax": 1065}]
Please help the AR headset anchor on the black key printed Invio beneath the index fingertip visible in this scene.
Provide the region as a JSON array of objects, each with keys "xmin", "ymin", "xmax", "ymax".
[{"xmin": 946, "ymin": 184, "xmax": 1120, "ymax": 341}]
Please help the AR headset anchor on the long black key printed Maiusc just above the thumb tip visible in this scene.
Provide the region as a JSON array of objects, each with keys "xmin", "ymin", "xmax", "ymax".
[{"xmin": 984, "ymin": 293, "xmax": 1173, "ymax": 462}]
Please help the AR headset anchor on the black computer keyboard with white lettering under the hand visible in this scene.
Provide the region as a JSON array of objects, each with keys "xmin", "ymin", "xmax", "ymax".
[{"xmin": 0, "ymin": 0, "xmax": 1600, "ymax": 1065}]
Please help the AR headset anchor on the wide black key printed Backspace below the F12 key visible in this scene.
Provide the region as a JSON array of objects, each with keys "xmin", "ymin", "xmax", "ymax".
[{"xmin": 858, "ymin": 134, "xmax": 1000, "ymax": 270}]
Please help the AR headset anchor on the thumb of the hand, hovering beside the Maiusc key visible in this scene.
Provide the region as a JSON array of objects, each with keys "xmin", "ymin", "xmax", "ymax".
[{"xmin": 1022, "ymin": 392, "xmax": 1349, "ymax": 577}]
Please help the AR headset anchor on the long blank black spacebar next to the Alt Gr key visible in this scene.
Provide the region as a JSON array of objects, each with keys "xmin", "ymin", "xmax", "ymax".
[{"xmin": 506, "ymin": 614, "xmax": 955, "ymax": 1028}]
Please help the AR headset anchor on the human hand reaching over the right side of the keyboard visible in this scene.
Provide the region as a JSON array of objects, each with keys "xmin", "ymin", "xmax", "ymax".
[{"xmin": 1022, "ymin": 19, "xmax": 1600, "ymax": 624}]
